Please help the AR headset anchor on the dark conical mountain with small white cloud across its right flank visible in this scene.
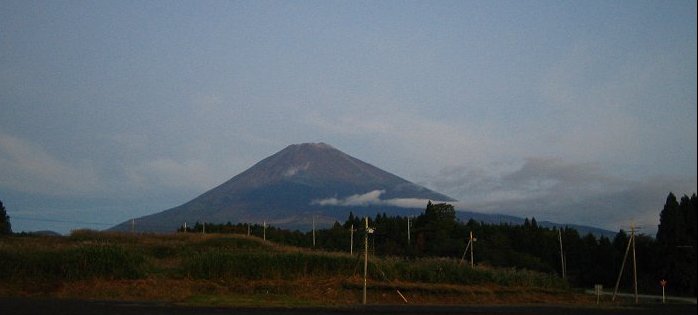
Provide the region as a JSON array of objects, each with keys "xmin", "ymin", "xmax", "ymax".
[{"xmin": 112, "ymin": 143, "xmax": 454, "ymax": 232}]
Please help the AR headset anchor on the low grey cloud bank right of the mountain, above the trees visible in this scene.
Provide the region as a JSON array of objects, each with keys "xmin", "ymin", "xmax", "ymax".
[{"xmin": 424, "ymin": 158, "xmax": 696, "ymax": 234}]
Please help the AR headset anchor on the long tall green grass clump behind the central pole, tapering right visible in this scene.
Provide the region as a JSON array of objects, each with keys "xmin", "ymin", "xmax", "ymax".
[{"xmin": 183, "ymin": 251, "xmax": 567, "ymax": 289}]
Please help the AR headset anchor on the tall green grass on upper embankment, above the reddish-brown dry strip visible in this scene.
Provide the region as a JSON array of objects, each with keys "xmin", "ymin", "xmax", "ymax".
[{"xmin": 0, "ymin": 231, "xmax": 566, "ymax": 288}]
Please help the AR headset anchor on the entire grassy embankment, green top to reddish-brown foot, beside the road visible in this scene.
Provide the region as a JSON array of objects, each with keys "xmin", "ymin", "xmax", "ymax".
[{"xmin": 0, "ymin": 231, "xmax": 590, "ymax": 306}]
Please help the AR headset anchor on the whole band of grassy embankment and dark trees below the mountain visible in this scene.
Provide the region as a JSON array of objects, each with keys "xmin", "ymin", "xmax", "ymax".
[{"xmin": 0, "ymin": 194, "xmax": 696, "ymax": 305}]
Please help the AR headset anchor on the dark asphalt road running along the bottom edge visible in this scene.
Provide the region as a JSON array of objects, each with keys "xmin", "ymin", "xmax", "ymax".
[{"xmin": 0, "ymin": 298, "xmax": 696, "ymax": 315}]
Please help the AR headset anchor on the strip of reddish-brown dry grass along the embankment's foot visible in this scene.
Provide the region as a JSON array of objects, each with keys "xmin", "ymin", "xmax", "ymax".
[{"xmin": 44, "ymin": 278, "xmax": 593, "ymax": 306}]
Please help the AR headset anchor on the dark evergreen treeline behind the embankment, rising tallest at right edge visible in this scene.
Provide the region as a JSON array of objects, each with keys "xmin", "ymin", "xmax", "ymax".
[{"xmin": 180, "ymin": 194, "xmax": 697, "ymax": 296}]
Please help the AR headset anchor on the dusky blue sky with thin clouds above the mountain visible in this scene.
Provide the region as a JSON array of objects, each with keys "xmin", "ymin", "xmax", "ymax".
[{"xmin": 0, "ymin": 0, "xmax": 697, "ymax": 234}]
